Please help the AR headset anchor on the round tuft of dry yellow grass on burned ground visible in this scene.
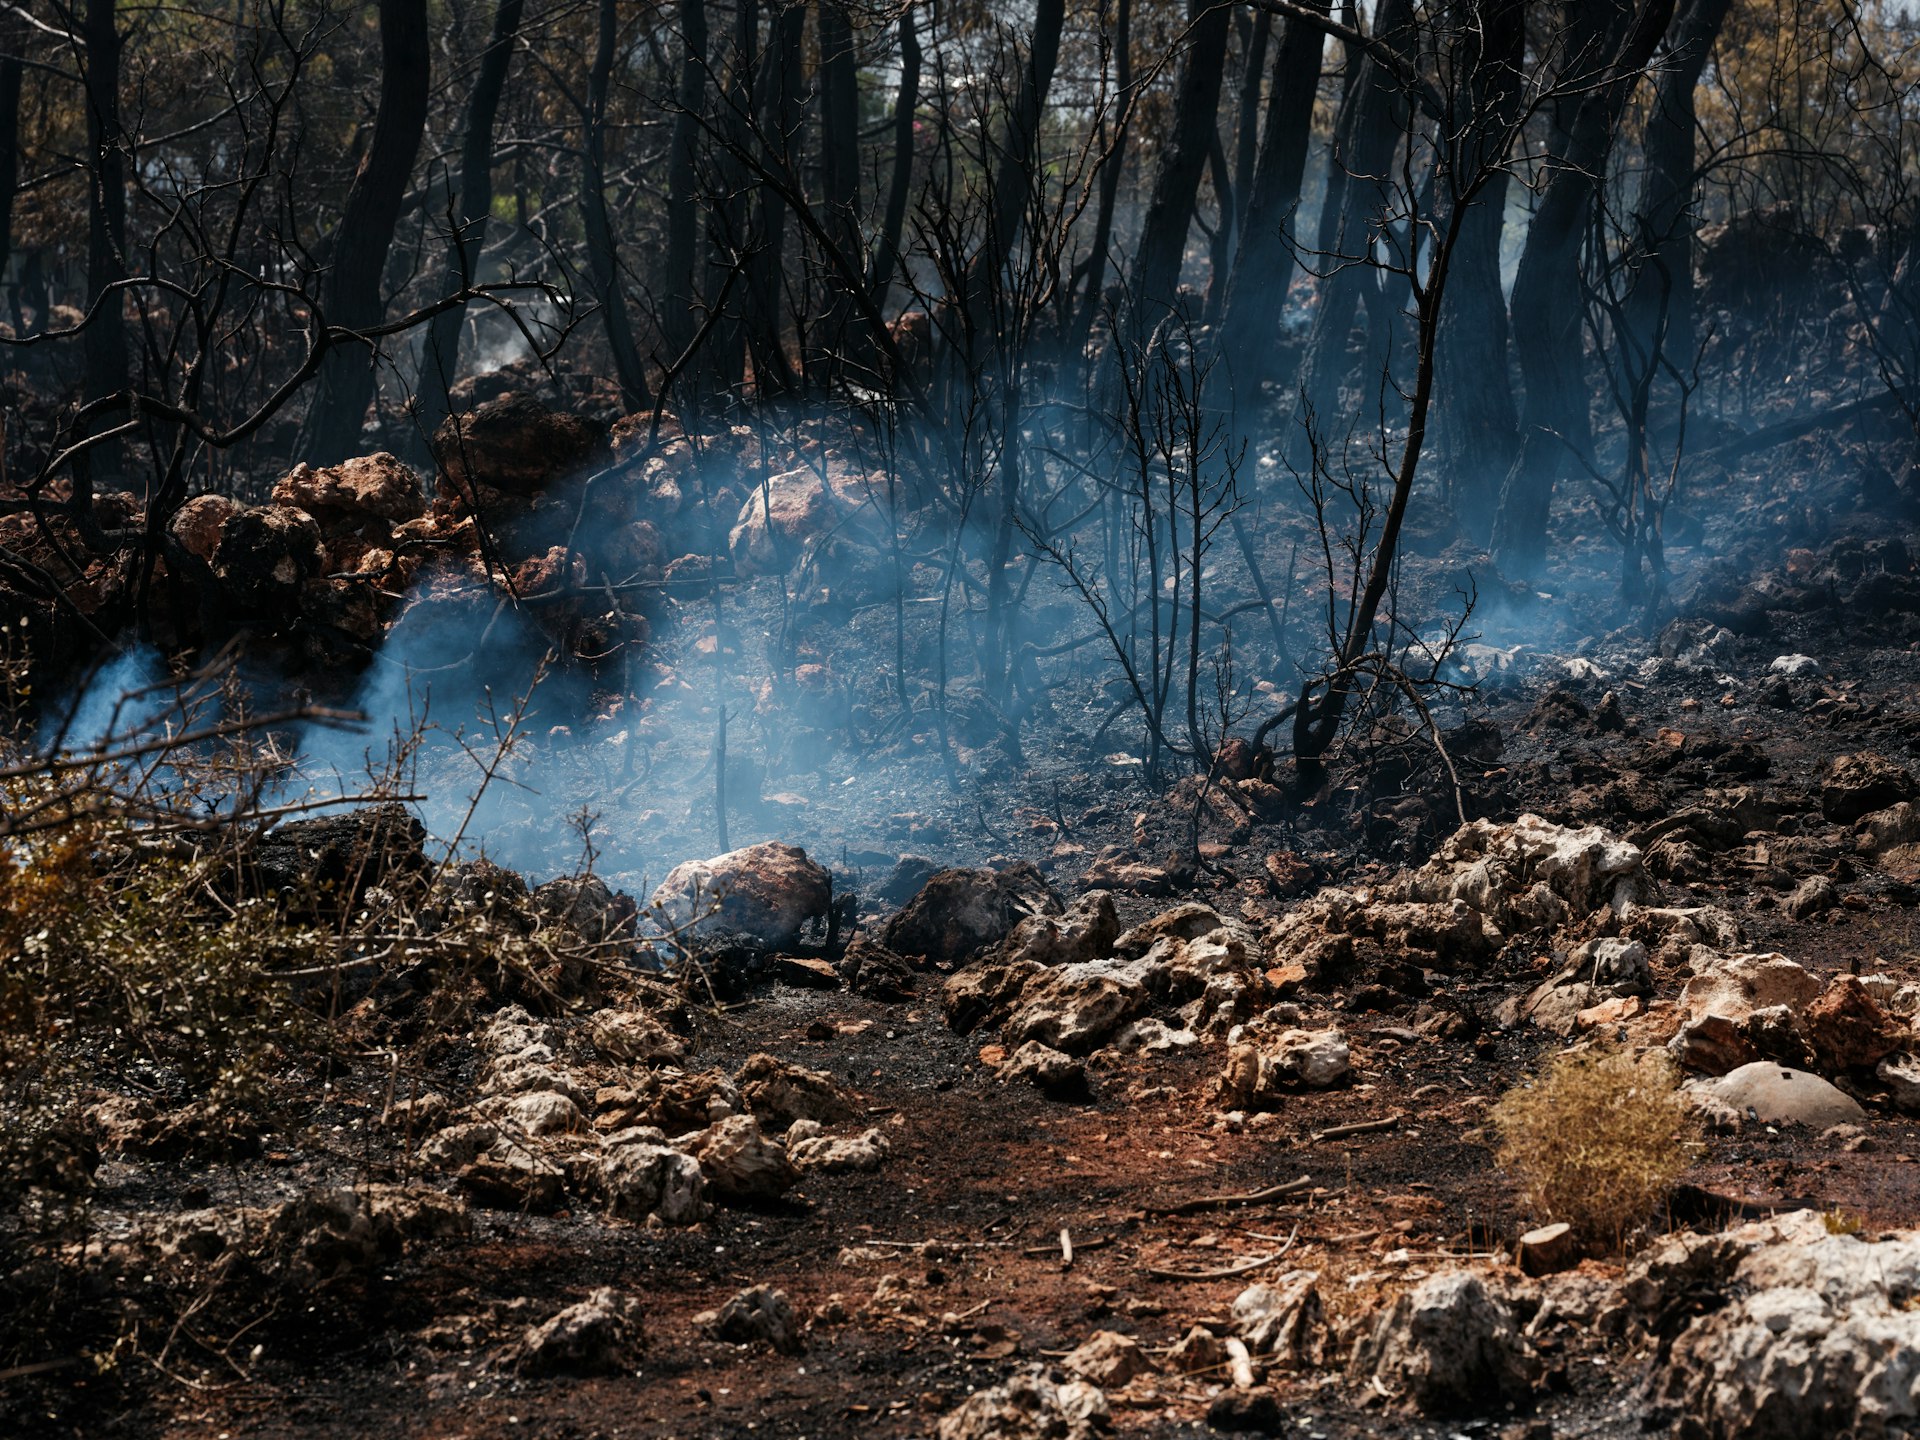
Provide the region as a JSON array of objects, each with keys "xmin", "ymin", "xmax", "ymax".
[{"xmin": 1492, "ymin": 1050, "xmax": 1699, "ymax": 1248}]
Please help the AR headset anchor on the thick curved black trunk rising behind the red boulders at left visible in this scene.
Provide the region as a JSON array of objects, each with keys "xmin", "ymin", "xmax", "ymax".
[{"xmin": 301, "ymin": 0, "xmax": 432, "ymax": 465}]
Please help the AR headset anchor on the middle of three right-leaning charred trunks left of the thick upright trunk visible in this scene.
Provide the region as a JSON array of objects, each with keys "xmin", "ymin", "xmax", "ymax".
[{"xmin": 1219, "ymin": 0, "xmax": 1327, "ymax": 388}]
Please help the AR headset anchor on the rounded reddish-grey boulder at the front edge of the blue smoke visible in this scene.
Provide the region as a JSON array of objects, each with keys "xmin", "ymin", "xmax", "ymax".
[{"xmin": 651, "ymin": 841, "xmax": 833, "ymax": 950}]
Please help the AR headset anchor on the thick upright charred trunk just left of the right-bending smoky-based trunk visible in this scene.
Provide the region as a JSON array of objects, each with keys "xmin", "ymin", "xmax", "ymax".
[{"xmin": 1434, "ymin": 0, "xmax": 1526, "ymax": 540}]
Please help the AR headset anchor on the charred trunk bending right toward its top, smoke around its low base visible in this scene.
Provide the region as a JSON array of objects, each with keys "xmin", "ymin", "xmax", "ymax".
[{"xmin": 1494, "ymin": 0, "xmax": 1674, "ymax": 574}]
